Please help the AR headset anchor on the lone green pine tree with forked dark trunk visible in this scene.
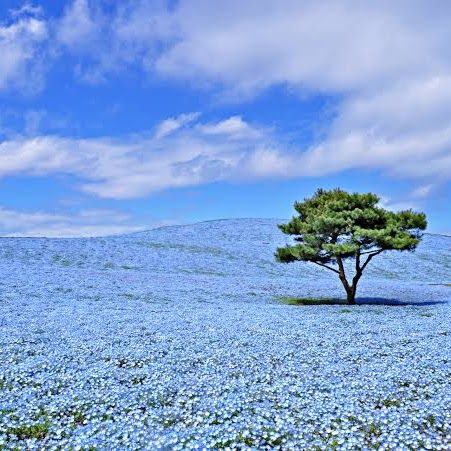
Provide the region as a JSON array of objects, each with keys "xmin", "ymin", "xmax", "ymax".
[{"xmin": 275, "ymin": 188, "xmax": 427, "ymax": 304}]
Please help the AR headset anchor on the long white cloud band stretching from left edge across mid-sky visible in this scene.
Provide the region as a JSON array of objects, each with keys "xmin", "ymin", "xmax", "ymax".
[{"xmin": 0, "ymin": 114, "xmax": 275, "ymax": 199}]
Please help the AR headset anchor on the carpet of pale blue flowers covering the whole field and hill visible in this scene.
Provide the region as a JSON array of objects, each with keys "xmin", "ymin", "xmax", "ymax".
[{"xmin": 0, "ymin": 220, "xmax": 451, "ymax": 450}]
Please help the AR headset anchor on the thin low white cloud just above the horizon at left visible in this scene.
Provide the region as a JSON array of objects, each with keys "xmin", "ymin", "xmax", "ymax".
[{"xmin": 0, "ymin": 207, "xmax": 152, "ymax": 238}]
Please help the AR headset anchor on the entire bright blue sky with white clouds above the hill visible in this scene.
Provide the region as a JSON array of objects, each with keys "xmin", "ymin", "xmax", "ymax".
[{"xmin": 0, "ymin": 0, "xmax": 451, "ymax": 237}]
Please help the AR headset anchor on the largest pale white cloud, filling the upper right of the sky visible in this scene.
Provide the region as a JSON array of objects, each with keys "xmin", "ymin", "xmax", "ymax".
[{"xmin": 149, "ymin": 1, "xmax": 451, "ymax": 187}]
